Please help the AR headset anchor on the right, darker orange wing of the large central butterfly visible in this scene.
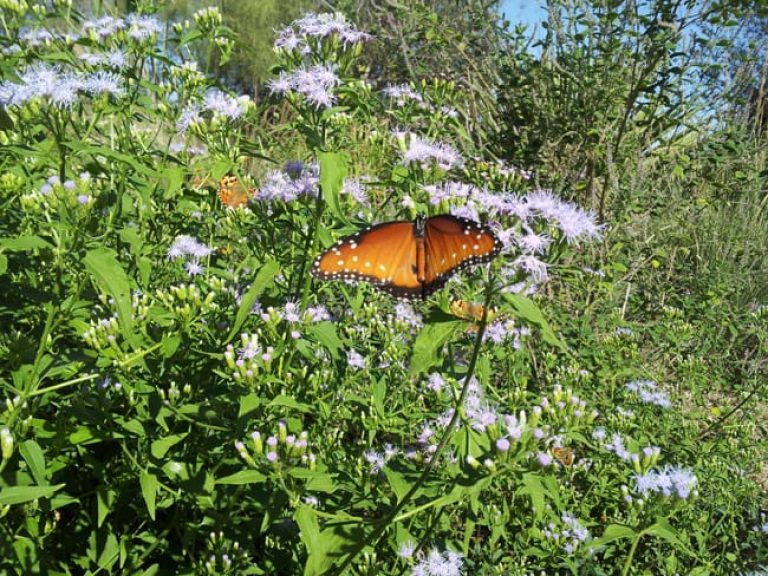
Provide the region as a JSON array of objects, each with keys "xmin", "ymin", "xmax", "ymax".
[{"xmin": 424, "ymin": 214, "xmax": 501, "ymax": 293}]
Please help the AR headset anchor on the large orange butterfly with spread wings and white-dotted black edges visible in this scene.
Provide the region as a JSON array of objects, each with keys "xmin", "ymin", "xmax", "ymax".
[{"xmin": 312, "ymin": 215, "xmax": 501, "ymax": 298}]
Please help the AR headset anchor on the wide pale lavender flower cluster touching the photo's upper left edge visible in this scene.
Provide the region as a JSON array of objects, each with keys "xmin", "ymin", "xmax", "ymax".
[{"xmin": 0, "ymin": 62, "xmax": 124, "ymax": 108}]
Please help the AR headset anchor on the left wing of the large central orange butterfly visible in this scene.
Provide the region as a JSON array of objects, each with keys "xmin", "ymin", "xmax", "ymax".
[{"xmin": 312, "ymin": 221, "xmax": 422, "ymax": 298}]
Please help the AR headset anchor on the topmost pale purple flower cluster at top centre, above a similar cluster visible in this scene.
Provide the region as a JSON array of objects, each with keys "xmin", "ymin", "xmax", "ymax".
[{"xmin": 275, "ymin": 12, "xmax": 370, "ymax": 55}]
